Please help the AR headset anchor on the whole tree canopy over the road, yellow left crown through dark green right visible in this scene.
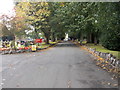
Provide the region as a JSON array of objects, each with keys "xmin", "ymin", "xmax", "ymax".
[{"xmin": 12, "ymin": 2, "xmax": 120, "ymax": 50}]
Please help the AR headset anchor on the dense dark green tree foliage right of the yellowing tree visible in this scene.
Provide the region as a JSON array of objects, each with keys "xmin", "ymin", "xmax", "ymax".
[{"xmin": 51, "ymin": 2, "xmax": 120, "ymax": 50}]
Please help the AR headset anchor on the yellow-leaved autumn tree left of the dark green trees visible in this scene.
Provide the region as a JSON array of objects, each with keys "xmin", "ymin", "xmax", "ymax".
[{"xmin": 16, "ymin": 2, "xmax": 50, "ymax": 43}]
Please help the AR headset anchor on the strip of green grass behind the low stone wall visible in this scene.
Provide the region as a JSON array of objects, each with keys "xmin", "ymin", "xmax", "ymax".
[{"xmin": 87, "ymin": 44, "xmax": 120, "ymax": 59}]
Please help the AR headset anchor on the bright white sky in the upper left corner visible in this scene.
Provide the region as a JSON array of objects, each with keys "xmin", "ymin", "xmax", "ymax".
[{"xmin": 0, "ymin": 0, "xmax": 14, "ymax": 17}]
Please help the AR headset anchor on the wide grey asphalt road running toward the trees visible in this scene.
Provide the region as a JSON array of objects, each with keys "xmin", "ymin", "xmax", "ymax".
[{"xmin": 1, "ymin": 42, "xmax": 117, "ymax": 88}]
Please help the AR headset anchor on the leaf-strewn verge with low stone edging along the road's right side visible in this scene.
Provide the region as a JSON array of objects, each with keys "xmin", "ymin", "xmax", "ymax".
[{"xmin": 73, "ymin": 42, "xmax": 120, "ymax": 79}]
